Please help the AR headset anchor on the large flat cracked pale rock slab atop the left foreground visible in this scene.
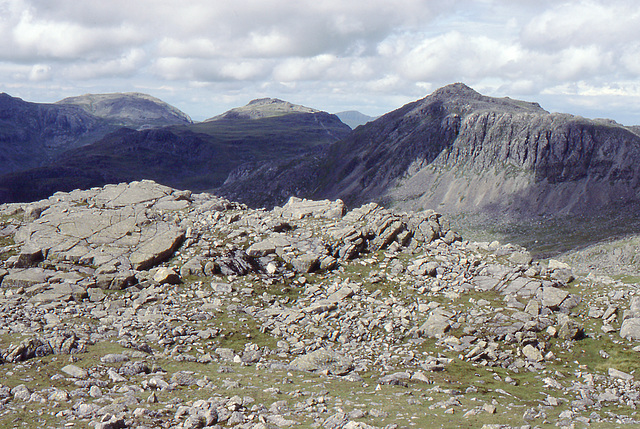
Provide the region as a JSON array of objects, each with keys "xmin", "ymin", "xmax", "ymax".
[{"xmin": 15, "ymin": 181, "xmax": 185, "ymax": 270}]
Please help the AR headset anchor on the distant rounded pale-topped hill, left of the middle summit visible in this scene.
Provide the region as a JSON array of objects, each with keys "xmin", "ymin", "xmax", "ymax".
[{"xmin": 56, "ymin": 92, "xmax": 192, "ymax": 129}]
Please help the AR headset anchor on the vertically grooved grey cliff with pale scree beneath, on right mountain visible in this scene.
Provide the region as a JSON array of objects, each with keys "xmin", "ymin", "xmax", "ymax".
[{"xmin": 385, "ymin": 112, "xmax": 640, "ymax": 215}]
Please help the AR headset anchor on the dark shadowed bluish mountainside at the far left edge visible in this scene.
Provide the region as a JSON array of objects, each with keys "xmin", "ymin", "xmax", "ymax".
[{"xmin": 0, "ymin": 93, "xmax": 116, "ymax": 175}]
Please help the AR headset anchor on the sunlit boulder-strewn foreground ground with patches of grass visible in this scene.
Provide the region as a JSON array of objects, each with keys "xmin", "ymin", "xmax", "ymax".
[{"xmin": 0, "ymin": 181, "xmax": 640, "ymax": 429}]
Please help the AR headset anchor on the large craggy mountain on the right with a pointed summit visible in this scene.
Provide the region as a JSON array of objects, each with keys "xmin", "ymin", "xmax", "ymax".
[{"xmin": 314, "ymin": 84, "xmax": 640, "ymax": 216}]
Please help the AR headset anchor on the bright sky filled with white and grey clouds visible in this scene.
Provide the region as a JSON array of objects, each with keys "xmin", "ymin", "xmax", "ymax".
[{"xmin": 0, "ymin": 0, "xmax": 640, "ymax": 125}]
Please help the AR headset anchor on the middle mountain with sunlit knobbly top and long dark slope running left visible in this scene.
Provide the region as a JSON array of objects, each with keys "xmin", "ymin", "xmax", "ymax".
[{"xmin": 0, "ymin": 99, "xmax": 351, "ymax": 201}]
